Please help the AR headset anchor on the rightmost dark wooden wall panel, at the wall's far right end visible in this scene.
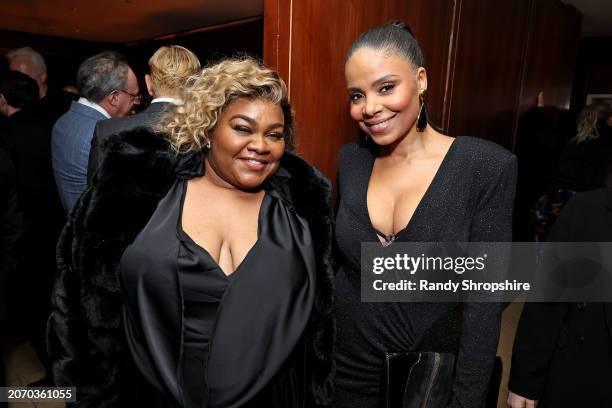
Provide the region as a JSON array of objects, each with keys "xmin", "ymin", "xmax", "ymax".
[{"xmin": 520, "ymin": 0, "xmax": 582, "ymax": 113}]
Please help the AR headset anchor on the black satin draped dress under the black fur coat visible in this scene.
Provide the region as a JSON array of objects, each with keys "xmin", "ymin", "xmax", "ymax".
[{"xmin": 121, "ymin": 155, "xmax": 315, "ymax": 408}]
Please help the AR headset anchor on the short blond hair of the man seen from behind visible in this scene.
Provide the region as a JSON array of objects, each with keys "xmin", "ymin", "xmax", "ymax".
[{"xmin": 149, "ymin": 45, "xmax": 200, "ymax": 95}]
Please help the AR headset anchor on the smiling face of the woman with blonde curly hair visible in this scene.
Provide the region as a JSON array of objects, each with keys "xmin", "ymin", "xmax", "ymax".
[{"xmin": 206, "ymin": 98, "xmax": 285, "ymax": 191}]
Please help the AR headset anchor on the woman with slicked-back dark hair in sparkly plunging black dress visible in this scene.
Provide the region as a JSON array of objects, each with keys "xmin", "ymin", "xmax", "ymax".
[{"xmin": 335, "ymin": 23, "xmax": 516, "ymax": 408}]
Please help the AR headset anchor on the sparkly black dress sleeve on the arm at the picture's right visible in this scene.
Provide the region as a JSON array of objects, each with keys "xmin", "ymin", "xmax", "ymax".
[{"xmin": 450, "ymin": 155, "xmax": 517, "ymax": 408}]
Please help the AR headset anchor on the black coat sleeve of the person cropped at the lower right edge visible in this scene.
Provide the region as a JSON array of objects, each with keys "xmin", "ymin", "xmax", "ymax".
[{"xmin": 508, "ymin": 194, "xmax": 580, "ymax": 400}]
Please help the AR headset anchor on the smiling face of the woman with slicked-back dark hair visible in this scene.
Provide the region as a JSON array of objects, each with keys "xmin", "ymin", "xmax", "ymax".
[{"xmin": 345, "ymin": 47, "xmax": 427, "ymax": 146}]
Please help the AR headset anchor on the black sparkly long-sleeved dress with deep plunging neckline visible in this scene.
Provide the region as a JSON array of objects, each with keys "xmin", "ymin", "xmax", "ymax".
[{"xmin": 335, "ymin": 137, "xmax": 516, "ymax": 408}]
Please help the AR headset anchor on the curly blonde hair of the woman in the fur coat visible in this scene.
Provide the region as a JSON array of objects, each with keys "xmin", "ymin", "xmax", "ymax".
[{"xmin": 158, "ymin": 57, "xmax": 293, "ymax": 153}]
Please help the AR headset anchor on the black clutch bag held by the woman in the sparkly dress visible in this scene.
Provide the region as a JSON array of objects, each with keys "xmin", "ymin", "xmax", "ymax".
[{"xmin": 382, "ymin": 351, "xmax": 455, "ymax": 408}]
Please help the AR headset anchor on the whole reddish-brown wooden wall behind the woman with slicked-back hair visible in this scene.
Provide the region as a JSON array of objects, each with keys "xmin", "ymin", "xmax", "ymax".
[{"xmin": 264, "ymin": 0, "xmax": 581, "ymax": 172}]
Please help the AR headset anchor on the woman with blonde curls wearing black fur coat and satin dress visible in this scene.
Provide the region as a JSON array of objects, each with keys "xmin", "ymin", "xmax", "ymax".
[{"xmin": 50, "ymin": 59, "xmax": 334, "ymax": 408}]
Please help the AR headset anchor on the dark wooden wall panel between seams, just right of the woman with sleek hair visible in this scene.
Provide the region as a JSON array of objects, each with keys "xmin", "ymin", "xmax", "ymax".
[{"xmin": 445, "ymin": 0, "xmax": 531, "ymax": 148}]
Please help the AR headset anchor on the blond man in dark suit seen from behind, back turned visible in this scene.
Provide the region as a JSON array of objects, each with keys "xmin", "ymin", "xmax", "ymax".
[{"xmin": 87, "ymin": 45, "xmax": 200, "ymax": 183}]
